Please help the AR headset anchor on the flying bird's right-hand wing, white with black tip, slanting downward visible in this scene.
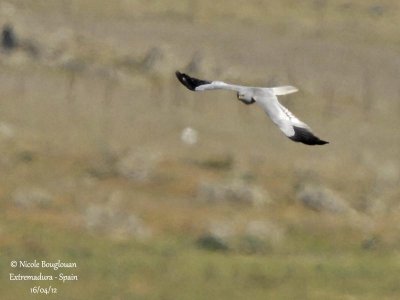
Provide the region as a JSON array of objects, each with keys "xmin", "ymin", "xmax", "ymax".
[{"xmin": 254, "ymin": 93, "xmax": 329, "ymax": 145}]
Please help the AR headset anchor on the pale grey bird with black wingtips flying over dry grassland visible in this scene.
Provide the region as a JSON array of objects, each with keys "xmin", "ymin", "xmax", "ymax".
[{"xmin": 175, "ymin": 71, "xmax": 328, "ymax": 145}]
